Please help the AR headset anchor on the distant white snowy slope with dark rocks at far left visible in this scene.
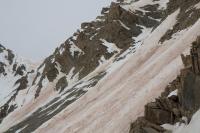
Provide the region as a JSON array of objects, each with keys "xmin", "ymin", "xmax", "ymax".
[{"xmin": 0, "ymin": 44, "xmax": 36, "ymax": 121}]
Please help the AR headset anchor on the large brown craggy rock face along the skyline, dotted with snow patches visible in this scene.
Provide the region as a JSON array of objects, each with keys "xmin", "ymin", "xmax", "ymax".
[{"xmin": 34, "ymin": 2, "xmax": 164, "ymax": 97}]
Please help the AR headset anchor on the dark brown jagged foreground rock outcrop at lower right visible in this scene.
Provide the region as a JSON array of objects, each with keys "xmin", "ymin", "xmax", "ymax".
[{"xmin": 130, "ymin": 37, "xmax": 200, "ymax": 133}]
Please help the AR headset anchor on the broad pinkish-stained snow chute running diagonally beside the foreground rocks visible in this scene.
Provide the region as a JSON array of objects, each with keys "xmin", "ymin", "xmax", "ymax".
[{"xmin": 30, "ymin": 10, "xmax": 200, "ymax": 133}]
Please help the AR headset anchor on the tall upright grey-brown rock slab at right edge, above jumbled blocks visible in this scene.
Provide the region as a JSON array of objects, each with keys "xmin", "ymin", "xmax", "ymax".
[{"xmin": 179, "ymin": 37, "xmax": 200, "ymax": 117}]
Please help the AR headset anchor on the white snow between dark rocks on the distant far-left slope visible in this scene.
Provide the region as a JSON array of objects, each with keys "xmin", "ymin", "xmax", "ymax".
[{"xmin": 0, "ymin": 49, "xmax": 37, "ymax": 106}]
